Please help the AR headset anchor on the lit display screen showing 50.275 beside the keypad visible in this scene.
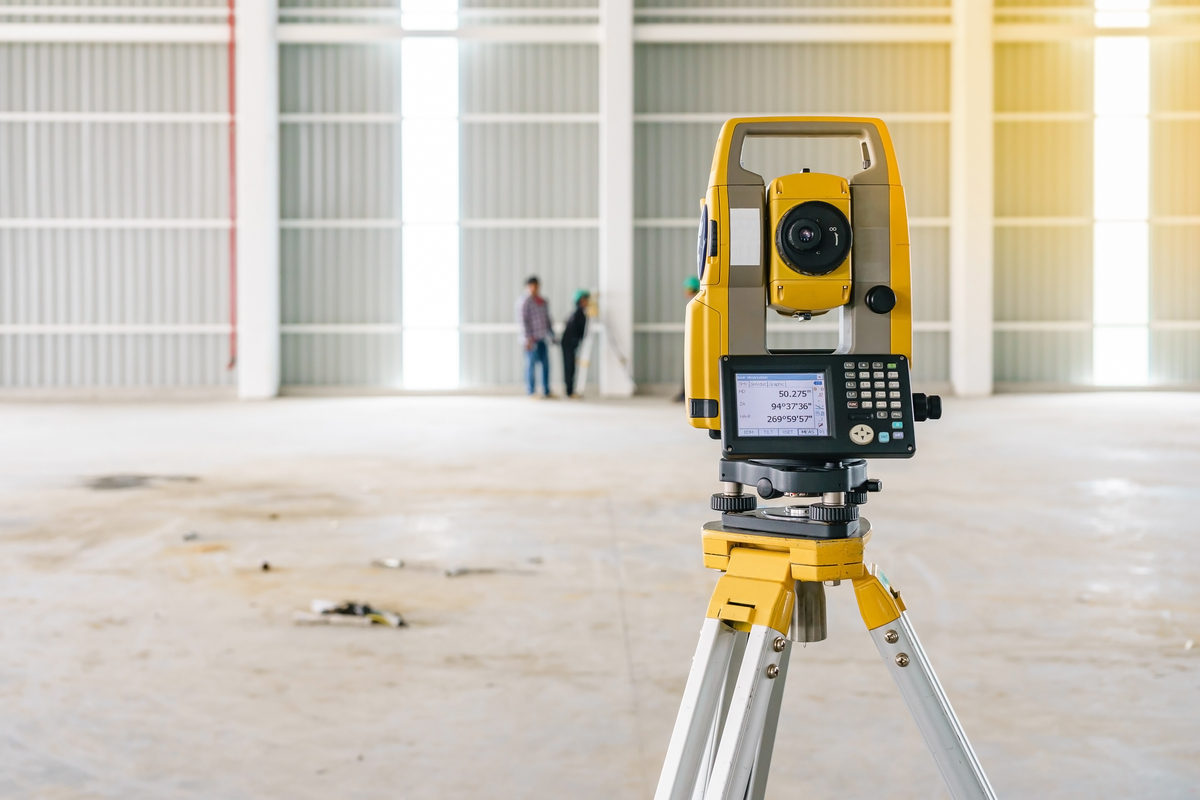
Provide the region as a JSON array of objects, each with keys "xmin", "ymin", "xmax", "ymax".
[{"xmin": 736, "ymin": 372, "xmax": 829, "ymax": 437}]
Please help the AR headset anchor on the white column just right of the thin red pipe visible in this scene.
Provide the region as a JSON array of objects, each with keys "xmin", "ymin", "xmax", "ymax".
[{"xmin": 235, "ymin": 0, "xmax": 280, "ymax": 399}]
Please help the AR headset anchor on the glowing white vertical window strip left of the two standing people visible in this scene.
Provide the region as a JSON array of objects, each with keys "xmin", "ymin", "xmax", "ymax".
[{"xmin": 400, "ymin": 35, "xmax": 458, "ymax": 389}]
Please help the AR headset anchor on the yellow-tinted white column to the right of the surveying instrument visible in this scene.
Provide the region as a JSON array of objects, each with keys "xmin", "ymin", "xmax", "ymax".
[{"xmin": 950, "ymin": 0, "xmax": 994, "ymax": 397}]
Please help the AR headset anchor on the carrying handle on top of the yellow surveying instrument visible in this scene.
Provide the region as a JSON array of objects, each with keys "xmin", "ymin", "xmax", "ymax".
[{"xmin": 726, "ymin": 118, "xmax": 899, "ymax": 186}]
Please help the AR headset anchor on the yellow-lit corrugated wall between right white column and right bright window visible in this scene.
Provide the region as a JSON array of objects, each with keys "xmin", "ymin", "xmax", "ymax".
[{"xmin": 995, "ymin": 40, "xmax": 1092, "ymax": 384}]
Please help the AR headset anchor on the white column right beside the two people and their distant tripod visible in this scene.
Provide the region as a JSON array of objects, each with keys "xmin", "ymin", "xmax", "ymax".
[{"xmin": 599, "ymin": 0, "xmax": 634, "ymax": 397}]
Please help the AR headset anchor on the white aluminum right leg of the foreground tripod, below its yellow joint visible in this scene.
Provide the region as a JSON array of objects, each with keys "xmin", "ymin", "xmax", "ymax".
[{"xmin": 871, "ymin": 613, "xmax": 996, "ymax": 800}]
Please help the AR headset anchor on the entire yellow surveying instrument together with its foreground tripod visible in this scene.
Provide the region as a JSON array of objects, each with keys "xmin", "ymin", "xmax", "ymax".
[{"xmin": 655, "ymin": 116, "xmax": 996, "ymax": 800}]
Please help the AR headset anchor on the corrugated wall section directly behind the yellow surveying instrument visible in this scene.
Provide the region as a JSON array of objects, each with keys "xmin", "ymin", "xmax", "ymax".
[{"xmin": 635, "ymin": 43, "xmax": 949, "ymax": 383}]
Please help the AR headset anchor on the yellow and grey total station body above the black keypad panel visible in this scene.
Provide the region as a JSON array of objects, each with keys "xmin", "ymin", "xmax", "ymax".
[{"xmin": 684, "ymin": 116, "xmax": 912, "ymax": 429}]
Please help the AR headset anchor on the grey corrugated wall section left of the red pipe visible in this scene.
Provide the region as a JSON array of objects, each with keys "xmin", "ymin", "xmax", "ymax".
[{"xmin": 0, "ymin": 38, "xmax": 234, "ymax": 389}]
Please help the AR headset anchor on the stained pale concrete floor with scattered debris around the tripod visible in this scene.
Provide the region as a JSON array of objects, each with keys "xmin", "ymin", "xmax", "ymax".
[{"xmin": 0, "ymin": 393, "xmax": 1200, "ymax": 800}]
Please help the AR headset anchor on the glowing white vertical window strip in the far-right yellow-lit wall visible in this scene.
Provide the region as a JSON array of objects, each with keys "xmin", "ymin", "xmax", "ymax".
[{"xmin": 1092, "ymin": 30, "xmax": 1150, "ymax": 386}]
